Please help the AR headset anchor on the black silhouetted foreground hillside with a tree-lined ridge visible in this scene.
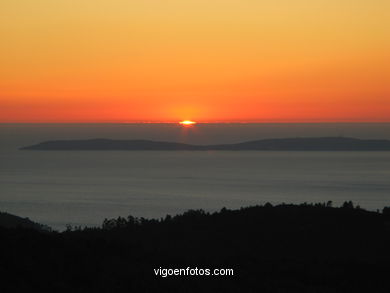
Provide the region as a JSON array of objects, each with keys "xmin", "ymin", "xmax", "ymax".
[{"xmin": 0, "ymin": 201, "xmax": 390, "ymax": 293}]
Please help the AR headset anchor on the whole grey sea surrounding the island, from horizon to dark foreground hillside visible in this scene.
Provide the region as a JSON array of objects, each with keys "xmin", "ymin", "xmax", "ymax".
[{"xmin": 0, "ymin": 123, "xmax": 390, "ymax": 230}]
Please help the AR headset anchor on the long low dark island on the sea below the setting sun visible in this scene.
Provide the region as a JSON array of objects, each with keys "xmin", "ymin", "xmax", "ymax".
[{"xmin": 21, "ymin": 137, "xmax": 390, "ymax": 151}]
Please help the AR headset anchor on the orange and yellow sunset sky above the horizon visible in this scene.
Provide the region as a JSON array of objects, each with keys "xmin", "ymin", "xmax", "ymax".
[{"xmin": 0, "ymin": 0, "xmax": 390, "ymax": 123}]
